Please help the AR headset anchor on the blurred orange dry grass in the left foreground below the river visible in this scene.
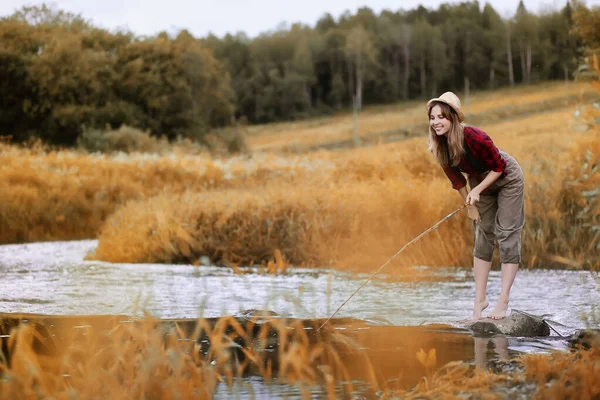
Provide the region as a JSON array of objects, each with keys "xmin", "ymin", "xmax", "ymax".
[{"xmin": 0, "ymin": 316, "xmax": 370, "ymax": 399}]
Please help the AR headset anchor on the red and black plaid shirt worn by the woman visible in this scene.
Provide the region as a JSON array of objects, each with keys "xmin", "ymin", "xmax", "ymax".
[{"xmin": 443, "ymin": 126, "xmax": 506, "ymax": 190}]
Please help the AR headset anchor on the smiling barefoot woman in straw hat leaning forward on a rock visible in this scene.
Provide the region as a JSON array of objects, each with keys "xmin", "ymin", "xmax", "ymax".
[{"xmin": 427, "ymin": 92, "xmax": 525, "ymax": 320}]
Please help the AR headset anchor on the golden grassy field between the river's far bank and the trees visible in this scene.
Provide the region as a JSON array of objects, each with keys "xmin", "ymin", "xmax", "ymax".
[{"xmin": 0, "ymin": 83, "xmax": 600, "ymax": 270}]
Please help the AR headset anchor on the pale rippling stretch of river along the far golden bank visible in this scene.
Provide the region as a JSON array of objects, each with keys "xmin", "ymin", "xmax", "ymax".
[{"xmin": 0, "ymin": 240, "xmax": 600, "ymax": 334}]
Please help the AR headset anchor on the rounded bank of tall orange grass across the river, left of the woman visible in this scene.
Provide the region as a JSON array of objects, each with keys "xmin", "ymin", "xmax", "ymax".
[{"xmin": 89, "ymin": 172, "xmax": 460, "ymax": 268}]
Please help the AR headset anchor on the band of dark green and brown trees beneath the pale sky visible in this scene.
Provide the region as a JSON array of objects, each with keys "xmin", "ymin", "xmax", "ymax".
[{"xmin": 0, "ymin": 0, "xmax": 587, "ymax": 145}]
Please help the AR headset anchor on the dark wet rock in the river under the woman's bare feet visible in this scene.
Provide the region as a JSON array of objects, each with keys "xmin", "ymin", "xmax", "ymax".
[{"xmin": 466, "ymin": 310, "xmax": 550, "ymax": 337}]
